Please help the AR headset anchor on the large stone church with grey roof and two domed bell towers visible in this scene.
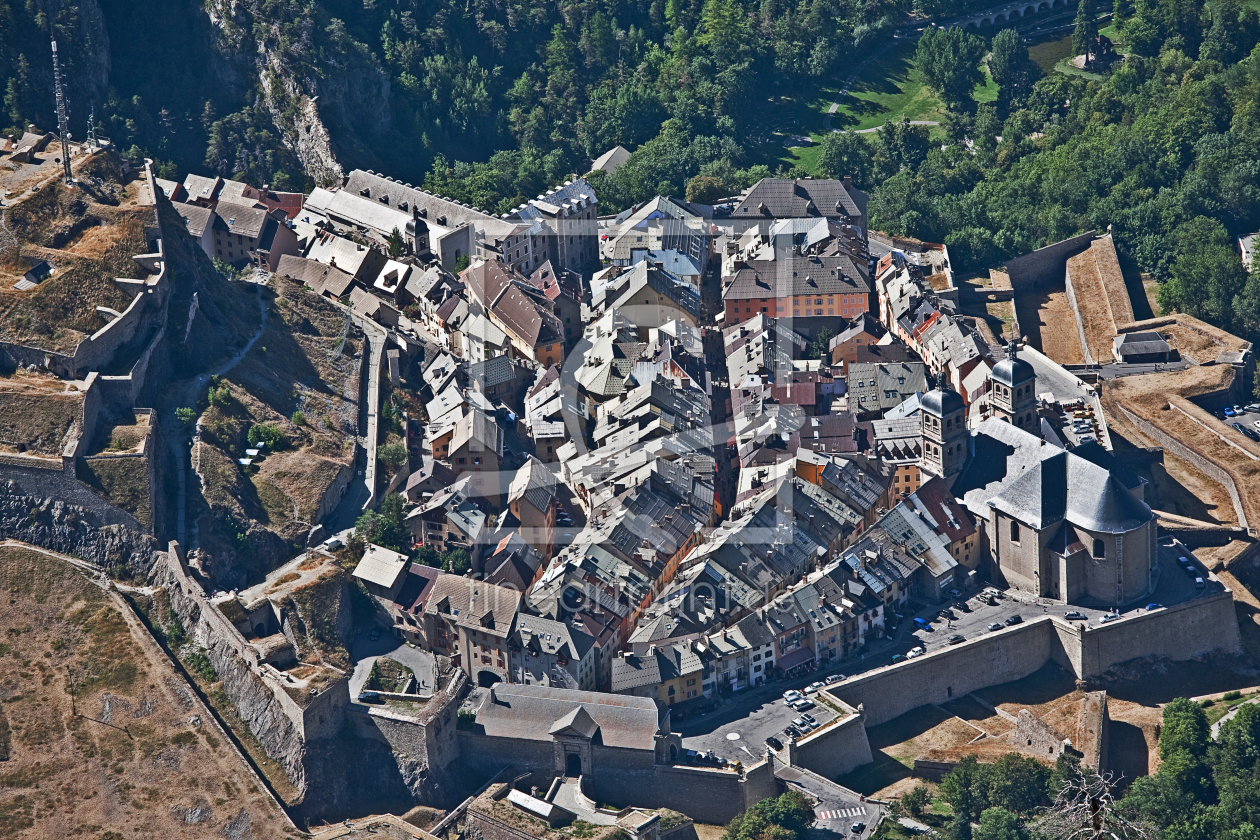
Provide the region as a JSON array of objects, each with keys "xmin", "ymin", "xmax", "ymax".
[{"xmin": 920, "ymin": 343, "xmax": 1158, "ymax": 607}]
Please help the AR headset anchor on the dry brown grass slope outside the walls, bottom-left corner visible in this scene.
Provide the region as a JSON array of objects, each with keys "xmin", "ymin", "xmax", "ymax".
[{"xmin": 0, "ymin": 545, "xmax": 286, "ymax": 840}]
